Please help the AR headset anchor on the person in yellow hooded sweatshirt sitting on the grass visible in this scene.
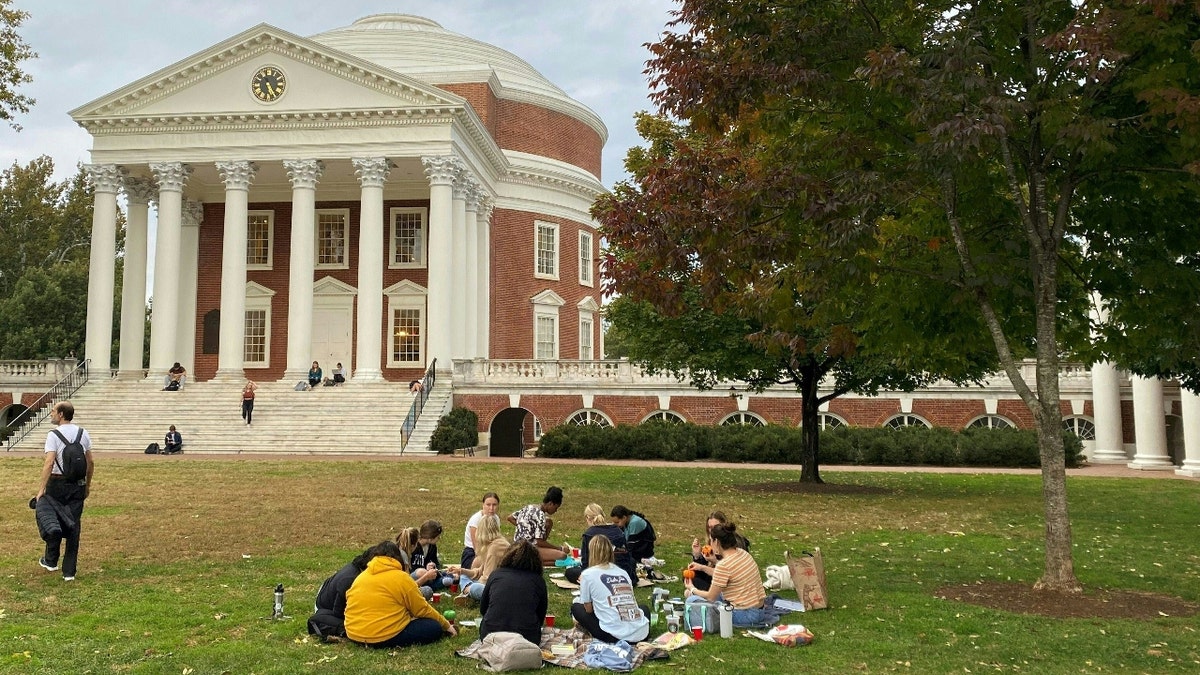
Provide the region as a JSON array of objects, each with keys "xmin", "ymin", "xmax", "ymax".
[{"xmin": 346, "ymin": 542, "xmax": 458, "ymax": 649}]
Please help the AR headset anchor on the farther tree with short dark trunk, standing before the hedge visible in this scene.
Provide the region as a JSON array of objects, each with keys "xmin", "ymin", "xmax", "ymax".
[{"xmin": 593, "ymin": 114, "xmax": 995, "ymax": 483}]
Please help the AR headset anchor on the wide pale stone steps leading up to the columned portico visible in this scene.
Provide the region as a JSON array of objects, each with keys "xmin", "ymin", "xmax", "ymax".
[{"xmin": 14, "ymin": 375, "xmax": 452, "ymax": 455}]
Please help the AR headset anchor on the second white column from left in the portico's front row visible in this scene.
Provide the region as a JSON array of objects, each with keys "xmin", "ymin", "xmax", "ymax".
[{"xmin": 149, "ymin": 162, "xmax": 192, "ymax": 374}]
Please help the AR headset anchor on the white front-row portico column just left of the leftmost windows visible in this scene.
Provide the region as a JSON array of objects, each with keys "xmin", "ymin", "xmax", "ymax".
[{"xmin": 216, "ymin": 160, "xmax": 258, "ymax": 381}]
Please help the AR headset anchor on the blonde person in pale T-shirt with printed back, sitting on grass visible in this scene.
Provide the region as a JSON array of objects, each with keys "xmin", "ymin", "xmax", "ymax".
[{"xmin": 571, "ymin": 534, "xmax": 650, "ymax": 645}]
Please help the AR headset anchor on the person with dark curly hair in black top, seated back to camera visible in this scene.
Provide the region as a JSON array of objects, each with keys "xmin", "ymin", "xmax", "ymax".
[{"xmin": 479, "ymin": 540, "xmax": 550, "ymax": 645}]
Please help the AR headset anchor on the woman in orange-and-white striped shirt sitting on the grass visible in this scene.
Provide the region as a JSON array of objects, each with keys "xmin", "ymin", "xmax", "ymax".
[{"xmin": 684, "ymin": 522, "xmax": 778, "ymax": 626}]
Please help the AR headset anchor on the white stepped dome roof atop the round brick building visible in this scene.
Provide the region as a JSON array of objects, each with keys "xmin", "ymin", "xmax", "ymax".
[{"xmin": 312, "ymin": 14, "xmax": 608, "ymax": 139}]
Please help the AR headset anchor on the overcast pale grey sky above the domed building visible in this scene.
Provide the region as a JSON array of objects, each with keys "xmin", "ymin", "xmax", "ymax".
[{"xmin": 0, "ymin": 0, "xmax": 676, "ymax": 187}]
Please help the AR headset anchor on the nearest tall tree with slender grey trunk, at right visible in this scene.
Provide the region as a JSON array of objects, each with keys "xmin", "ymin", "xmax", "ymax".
[{"xmin": 633, "ymin": 0, "xmax": 1200, "ymax": 591}]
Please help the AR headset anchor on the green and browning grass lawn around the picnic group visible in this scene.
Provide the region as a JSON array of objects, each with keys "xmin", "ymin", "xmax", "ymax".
[{"xmin": 0, "ymin": 455, "xmax": 1200, "ymax": 675}]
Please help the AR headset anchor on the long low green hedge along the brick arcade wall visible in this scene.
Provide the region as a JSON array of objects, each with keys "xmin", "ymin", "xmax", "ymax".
[{"xmin": 538, "ymin": 423, "xmax": 1084, "ymax": 467}]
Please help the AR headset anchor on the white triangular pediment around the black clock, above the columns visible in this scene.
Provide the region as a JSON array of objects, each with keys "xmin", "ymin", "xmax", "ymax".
[{"xmin": 71, "ymin": 24, "xmax": 466, "ymax": 126}]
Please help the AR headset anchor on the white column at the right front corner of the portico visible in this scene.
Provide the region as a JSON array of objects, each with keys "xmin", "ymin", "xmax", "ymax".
[{"xmin": 421, "ymin": 155, "xmax": 462, "ymax": 371}]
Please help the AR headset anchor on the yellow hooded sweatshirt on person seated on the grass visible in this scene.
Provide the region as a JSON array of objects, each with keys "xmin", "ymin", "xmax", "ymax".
[{"xmin": 346, "ymin": 556, "xmax": 450, "ymax": 644}]
